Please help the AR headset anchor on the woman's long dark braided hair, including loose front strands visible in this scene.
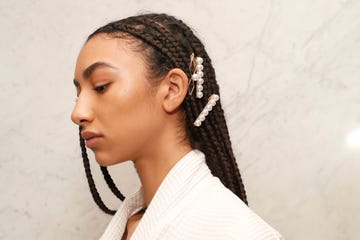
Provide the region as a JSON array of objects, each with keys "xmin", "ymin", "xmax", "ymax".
[{"xmin": 80, "ymin": 13, "xmax": 248, "ymax": 214}]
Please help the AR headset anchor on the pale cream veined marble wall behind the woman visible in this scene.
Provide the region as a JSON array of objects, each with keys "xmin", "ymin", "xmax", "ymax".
[{"xmin": 0, "ymin": 0, "xmax": 360, "ymax": 240}]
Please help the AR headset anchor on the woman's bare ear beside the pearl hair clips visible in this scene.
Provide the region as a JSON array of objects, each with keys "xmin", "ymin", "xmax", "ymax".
[{"xmin": 159, "ymin": 68, "xmax": 188, "ymax": 113}]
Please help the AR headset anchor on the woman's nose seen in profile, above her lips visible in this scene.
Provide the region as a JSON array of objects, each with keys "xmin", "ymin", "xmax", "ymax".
[{"xmin": 71, "ymin": 96, "xmax": 94, "ymax": 126}]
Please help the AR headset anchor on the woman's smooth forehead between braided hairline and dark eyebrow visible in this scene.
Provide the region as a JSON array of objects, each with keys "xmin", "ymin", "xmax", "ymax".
[{"xmin": 75, "ymin": 34, "xmax": 145, "ymax": 79}]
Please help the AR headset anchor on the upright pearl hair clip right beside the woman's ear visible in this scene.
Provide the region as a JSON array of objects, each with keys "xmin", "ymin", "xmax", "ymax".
[{"xmin": 190, "ymin": 53, "xmax": 204, "ymax": 98}]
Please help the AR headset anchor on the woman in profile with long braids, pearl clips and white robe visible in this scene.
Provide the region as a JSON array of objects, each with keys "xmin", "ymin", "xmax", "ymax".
[{"xmin": 72, "ymin": 14, "xmax": 280, "ymax": 240}]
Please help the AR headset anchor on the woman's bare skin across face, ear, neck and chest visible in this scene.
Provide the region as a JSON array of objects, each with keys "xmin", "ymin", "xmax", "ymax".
[{"xmin": 71, "ymin": 34, "xmax": 191, "ymax": 238}]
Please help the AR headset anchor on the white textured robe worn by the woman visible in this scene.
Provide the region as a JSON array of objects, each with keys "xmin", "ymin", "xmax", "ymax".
[{"xmin": 100, "ymin": 150, "xmax": 282, "ymax": 240}]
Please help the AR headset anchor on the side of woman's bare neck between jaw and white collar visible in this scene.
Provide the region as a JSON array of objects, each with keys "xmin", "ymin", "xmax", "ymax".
[{"xmin": 134, "ymin": 141, "xmax": 192, "ymax": 206}]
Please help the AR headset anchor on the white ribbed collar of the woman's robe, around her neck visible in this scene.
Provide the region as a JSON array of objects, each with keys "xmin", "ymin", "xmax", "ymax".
[{"xmin": 102, "ymin": 150, "xmax": 210, "ymax": 239}]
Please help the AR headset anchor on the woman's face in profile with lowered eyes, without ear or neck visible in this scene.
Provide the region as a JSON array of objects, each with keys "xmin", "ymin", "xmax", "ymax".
[{"xmin": 71, "ymin": 34, "xmax": 162, "ymax": 166}]
